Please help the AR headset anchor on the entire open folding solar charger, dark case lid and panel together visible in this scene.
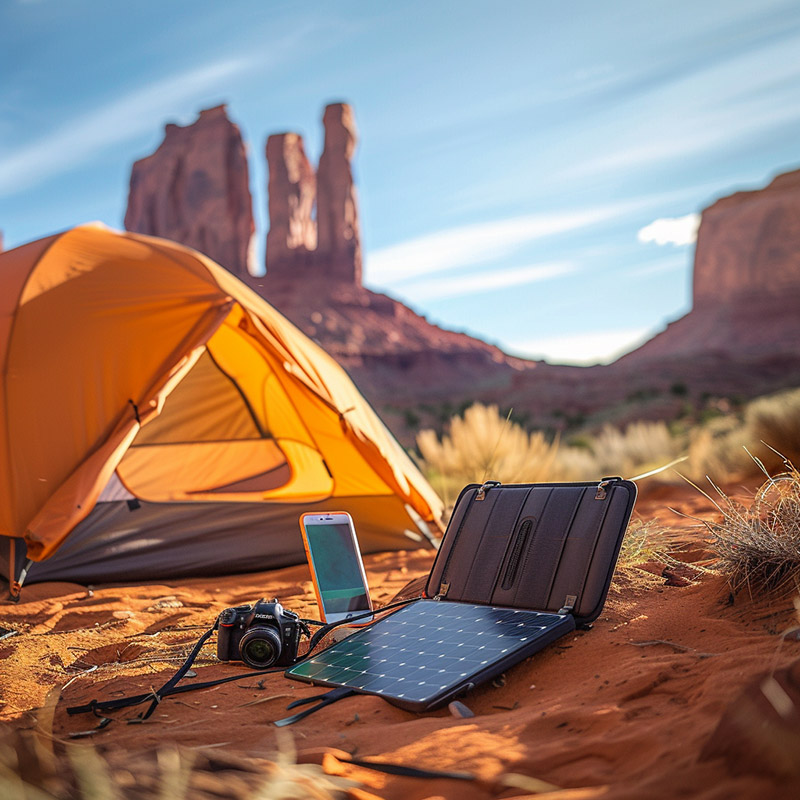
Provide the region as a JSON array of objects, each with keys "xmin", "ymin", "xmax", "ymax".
[{"xmin": 286, "ymin": 478, "xmax": 636, "ymax": 711}]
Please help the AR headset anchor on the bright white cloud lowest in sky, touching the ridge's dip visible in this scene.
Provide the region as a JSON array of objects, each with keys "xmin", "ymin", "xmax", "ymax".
[{"xmin": 510, "ymin": 328, "xmax": 652, "ymax": 366}]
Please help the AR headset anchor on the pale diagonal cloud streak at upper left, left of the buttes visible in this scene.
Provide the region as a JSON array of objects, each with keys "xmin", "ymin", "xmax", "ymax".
[{"xmin": 0, "ymin": 58, "xmax": 254, "ymax": 196}]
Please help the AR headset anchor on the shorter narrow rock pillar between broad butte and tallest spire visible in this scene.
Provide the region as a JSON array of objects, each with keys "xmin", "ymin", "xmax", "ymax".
[{"xmin": 266, "ymin": 133, "xmax": 317, "ymax": 280}]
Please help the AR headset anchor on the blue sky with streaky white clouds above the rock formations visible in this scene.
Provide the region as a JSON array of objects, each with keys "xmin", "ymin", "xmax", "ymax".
[{"xmin": 0, "ymin": 0, "xmax": 800, "ymax": 363}]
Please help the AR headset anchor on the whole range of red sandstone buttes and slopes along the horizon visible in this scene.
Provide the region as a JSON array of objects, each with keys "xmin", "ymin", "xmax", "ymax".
[{"xmin": 126, "ymin": 103, "xmax": 800, "ymax": 442}]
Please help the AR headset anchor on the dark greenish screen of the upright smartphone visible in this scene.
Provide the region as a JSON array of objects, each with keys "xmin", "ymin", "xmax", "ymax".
[{"xmin": 305, "ymin": 523, "xmax": 369, "ymax": 614}]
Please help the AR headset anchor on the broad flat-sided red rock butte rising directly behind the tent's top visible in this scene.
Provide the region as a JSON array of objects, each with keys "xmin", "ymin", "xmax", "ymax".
[{"xmin": 125, "ymin": 105, "xmax": 255, "ymax": 277}]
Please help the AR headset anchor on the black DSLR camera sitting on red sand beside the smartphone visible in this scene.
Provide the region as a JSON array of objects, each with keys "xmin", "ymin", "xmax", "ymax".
[{"xmin": 217, "ymin": 598, "xmax": 308, "ymax": 669}]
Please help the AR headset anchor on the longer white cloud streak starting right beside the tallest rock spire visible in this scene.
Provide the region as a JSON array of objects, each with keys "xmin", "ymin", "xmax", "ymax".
[{"xmin": 366, "ymin": 204, "xmax": 621, "ymax": 285}]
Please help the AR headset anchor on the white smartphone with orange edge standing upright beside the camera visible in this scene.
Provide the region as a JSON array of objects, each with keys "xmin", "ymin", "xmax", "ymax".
[{"xmin": 300, "ymin": 511, "xmax": 372, "ymax": 625}]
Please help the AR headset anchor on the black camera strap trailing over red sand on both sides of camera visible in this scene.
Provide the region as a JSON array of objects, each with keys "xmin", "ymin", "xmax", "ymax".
[{"xmin": 67, "ymin": 597, "xmax": 420, "ymax": 735}]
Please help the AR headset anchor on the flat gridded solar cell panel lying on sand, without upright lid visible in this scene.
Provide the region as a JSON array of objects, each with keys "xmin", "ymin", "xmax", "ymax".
[{"xmin": 286, "ymin": 599, "xmax": 575, "ymax": 711}]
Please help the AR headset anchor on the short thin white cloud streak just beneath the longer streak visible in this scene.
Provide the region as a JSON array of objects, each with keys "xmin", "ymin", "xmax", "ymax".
[{"xmin": 398, "ymin": 262, "xmax": 578, "ymax": 302}]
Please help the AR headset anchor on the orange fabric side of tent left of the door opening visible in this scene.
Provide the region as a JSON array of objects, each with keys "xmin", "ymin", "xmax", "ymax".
[{"xmin": 2, "ymin": 228, "xmax": 230, "ymax": 552}]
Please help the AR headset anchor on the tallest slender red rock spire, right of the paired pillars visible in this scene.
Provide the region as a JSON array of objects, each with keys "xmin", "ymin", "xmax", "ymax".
[{"xmin": 317, "ymin": 103, "xmax": 361, "ymax": 285}]
